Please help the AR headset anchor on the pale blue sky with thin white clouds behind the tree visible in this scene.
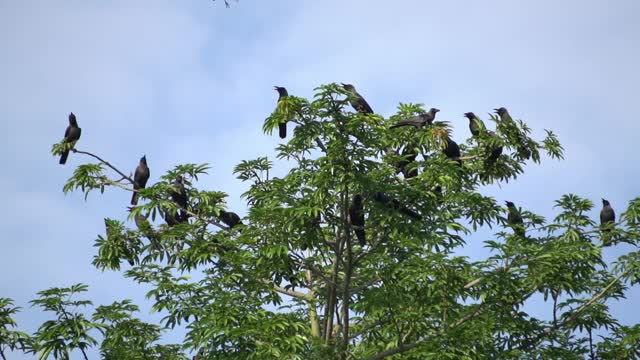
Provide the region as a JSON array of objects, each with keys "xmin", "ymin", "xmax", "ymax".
[{"xmin": 0, "ymin": 0, "xmax": 640, "ymax": 359}]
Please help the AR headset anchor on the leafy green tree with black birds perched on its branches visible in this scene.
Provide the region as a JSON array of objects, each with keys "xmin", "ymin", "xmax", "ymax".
[{"xmin": 6, "ymin": 84, "xmax": 640, "ymax": 360}]
